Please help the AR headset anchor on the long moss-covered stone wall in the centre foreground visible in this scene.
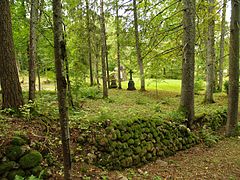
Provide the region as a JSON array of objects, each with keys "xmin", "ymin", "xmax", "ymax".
[{"xmin": 80, "ymin": 119, "xmax": 199, "ymax": 169}]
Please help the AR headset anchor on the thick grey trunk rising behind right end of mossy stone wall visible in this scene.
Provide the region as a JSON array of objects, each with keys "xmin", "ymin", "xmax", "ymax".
[{"xmin": 180, "ymin": 0, "xmax": 196, "ymax": 127}]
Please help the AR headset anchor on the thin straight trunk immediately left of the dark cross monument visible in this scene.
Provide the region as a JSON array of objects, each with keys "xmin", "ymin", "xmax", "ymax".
[{"xmin": 116, "ymin": 1, "xmax": 122, "ymax": 89}]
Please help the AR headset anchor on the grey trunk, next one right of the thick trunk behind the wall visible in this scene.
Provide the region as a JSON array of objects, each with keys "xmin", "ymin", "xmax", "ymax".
[{"xmin": 205, "ymin": 0, "xmax": 215, "ymax": 103}]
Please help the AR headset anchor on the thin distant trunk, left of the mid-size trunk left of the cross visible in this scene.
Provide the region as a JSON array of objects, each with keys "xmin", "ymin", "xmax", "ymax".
[{"xmin": 86, "ymin": 0, "xmax": 94, "ymax": 86}]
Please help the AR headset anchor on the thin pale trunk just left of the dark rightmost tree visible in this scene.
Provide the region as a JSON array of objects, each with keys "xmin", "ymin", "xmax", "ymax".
[{"xmin": 218, "ymin": 0, "xmax": 227, "ymax": 92}]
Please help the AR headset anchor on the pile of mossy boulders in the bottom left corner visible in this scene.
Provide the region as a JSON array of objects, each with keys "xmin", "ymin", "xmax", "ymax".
[{"xmin": 0, "ymin": 136, "xmax": 43, "ymax": 180}]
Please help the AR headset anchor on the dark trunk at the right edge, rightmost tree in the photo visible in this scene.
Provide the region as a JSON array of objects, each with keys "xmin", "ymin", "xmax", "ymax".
[{"xmin": 227, "ymin": 0, "xmax": 240, "ymax": 136}]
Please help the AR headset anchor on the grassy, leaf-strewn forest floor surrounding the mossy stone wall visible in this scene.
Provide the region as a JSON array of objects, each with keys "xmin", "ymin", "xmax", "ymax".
[{"xmin": 0, "ymin": 85, "xmax": 240, "ymax": 180}]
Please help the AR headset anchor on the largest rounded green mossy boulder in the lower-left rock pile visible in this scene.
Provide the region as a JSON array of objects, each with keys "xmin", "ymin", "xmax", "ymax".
[{"xmin": 19, "ymin": 150, "xmax": 42, "ymax": 169}]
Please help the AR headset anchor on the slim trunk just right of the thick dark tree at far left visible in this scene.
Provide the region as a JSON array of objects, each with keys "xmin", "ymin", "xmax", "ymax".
[{"xmin": 28, "ymin": 0, "xmax": 38, "ymax": 101}]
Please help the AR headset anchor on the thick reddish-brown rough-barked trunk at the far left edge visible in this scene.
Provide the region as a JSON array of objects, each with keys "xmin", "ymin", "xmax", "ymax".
[{"xmin": 0, "ymin": 0, "xmax": 23, "ymax": 108}]
